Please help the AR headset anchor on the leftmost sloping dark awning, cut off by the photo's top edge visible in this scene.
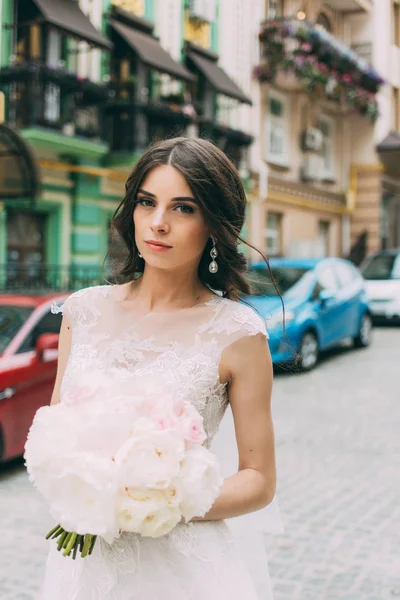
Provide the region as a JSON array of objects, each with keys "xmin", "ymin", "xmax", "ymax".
[{"xmin": 33, "ymin": 0, "xmax": 112, "ymax": 50}]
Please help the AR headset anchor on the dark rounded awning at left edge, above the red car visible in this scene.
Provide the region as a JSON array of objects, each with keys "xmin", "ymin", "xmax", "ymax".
[{"xmin": 0, "ymin": 124, "xmax": 39, "ymax": 201}]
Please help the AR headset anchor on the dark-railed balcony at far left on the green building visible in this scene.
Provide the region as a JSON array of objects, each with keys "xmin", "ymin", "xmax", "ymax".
[{"xmin": 0, "ymin": 62, "xmax": 107, "ymax": 140}]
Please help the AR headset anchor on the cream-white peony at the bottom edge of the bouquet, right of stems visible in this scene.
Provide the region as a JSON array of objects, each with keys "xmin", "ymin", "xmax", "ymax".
[{"xmin": 117, "ymin": 488, "xmax": 181, "ymax": 538}]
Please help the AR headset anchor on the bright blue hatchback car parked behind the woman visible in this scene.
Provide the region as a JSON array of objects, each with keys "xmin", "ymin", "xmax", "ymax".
[{"xmin": 244, "ymin": 258, "xmax": 372, "ymax": 371}]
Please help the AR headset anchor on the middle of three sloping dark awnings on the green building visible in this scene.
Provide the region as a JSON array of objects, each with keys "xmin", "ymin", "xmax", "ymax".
[{"xmin": 110, "ymin": 19, "xmax": 195, "ymax": 81}]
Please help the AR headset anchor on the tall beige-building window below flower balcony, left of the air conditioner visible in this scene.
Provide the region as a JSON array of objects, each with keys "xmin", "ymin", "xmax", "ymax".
[{"xmin": 265, "ymin": 92, "xmax": 289, "ymax": 166}]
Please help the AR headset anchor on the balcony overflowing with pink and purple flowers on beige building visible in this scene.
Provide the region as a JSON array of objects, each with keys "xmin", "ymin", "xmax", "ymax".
[{"xmin": 254, "ymin": 18, "xmax": 384, "ymax": 121}]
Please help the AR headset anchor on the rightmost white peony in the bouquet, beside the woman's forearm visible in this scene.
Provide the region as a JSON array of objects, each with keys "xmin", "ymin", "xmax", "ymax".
[{"xmin": 177, "ymin": 446, "xmax": 223, "ymax": 521}]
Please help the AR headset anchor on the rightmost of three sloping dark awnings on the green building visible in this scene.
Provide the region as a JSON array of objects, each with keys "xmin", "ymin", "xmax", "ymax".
[{"xmin": 186, "ymin": 45, "xmax": 252, "ymax": 104}]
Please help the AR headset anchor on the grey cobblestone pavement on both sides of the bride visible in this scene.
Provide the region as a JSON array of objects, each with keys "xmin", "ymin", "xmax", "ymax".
[{"xmin": 0, "ymin": 328, "xmax": 400, "ymax": 600}]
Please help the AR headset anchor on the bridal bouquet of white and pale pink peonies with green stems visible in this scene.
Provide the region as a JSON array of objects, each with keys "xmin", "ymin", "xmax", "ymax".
[{"xmin": 24, "ymin": 374, "xmax": 222, "ymax": 559}]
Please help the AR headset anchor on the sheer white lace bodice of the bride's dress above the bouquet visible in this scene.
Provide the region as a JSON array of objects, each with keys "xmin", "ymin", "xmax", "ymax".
[{"xmin": 53, "ymin": 285, "xmax": 266, "ymax": 446}]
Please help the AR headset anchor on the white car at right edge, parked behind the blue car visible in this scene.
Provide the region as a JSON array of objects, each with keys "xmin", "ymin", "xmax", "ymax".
[{"xmin": 360, "ymin": 248, "xmax": 400, "ymax": 323}]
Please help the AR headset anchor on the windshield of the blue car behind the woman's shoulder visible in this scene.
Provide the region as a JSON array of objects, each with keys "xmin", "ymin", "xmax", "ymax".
[{"xmin": 248, "ymin": 267, "xmax": 309, "ymax": 296}]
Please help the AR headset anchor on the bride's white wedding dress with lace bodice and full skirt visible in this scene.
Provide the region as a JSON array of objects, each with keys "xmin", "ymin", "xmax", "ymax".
[{"xmin": 38, "ymin": 286, "xmax": 280, "ymax": 600}]
